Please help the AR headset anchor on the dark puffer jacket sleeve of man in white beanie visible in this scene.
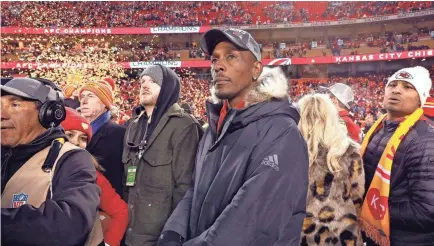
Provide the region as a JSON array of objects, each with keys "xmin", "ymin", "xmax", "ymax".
[{"xmin": 389, "ymin": 131, "xmax": 434, "ymax": 232}]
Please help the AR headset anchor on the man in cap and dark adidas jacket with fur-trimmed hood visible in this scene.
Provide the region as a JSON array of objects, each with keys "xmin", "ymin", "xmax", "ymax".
[{"xmin": 158, "ymin": 29, "xmax": 309, "ymax": 246}]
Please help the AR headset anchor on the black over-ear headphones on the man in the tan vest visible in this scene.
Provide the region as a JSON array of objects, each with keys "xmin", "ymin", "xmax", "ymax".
[{"xmin": 32, "ymin": 78, "xmax": 66, "ymax": 129}]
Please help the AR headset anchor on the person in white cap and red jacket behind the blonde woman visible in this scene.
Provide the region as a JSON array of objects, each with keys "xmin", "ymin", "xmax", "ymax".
[{"xmin": 327, "ymin": 83, "xmax": 360, "ymax": 143}]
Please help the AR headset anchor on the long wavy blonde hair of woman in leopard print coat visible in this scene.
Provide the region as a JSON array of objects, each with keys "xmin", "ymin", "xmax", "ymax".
[{"xmin": 298, "ymin": 94, "xmax": 358, "ymax": 172}]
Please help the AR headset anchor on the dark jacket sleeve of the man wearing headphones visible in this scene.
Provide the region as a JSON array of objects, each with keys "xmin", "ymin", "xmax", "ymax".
[{"xmin": 1, "ymin": 150, "xmax": 100, "ymax": 246}]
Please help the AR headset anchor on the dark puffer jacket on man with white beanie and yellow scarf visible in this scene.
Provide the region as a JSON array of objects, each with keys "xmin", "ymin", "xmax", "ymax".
[{"xmin": 363, "ymin": 118, "xmax": 434, "ymax": 246}]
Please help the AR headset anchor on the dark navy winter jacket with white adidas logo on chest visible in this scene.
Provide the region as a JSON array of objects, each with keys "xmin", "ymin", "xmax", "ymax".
[{"xmin": 164, "ymin": 99, "xmax": 309, "ymax": 246}]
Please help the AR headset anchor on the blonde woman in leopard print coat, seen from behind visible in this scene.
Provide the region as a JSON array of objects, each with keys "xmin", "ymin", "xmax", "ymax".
[{"xmin": 299, "ymin": 94, "xmax": 365, "ymax": 246}]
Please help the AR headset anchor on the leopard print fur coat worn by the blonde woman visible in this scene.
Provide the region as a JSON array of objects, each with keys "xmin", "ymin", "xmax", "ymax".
[{"xmin": 301, "ymin": 145, "xmax": 365, "ymax": 246}]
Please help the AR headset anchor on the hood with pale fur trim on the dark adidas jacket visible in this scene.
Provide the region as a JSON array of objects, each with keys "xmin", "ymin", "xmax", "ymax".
[{"xmin": 207, "ymin": 67, "xmax": 300, "ymax": 129}]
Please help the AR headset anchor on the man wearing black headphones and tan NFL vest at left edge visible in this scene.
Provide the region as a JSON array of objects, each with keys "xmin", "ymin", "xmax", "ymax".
[{"xmin": 1, "ymin": 78, "xmax": 100, "ymax": 245}]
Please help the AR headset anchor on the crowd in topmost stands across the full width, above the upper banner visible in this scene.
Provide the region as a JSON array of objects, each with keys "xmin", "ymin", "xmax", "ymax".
[{"xmin": 1, "ymin": 1, "xmax": 434, "ymax": 28}]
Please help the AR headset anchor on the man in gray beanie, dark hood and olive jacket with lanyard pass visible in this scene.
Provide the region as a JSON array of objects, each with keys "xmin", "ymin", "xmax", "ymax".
[{"xmin": 122, "ymin": 65, "xmax": 202, "ymax": 246}]
